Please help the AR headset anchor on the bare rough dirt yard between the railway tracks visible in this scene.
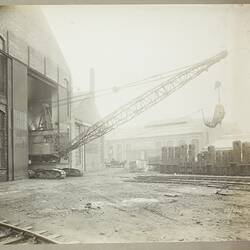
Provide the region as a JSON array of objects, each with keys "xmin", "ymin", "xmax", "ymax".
[{"xmin": 0, "ymin": 169, "xmax": 250, "ymax": 243}]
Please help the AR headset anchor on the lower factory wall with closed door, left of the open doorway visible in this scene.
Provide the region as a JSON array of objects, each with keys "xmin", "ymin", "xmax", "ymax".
[{"xmin": 0, "ymin": 54, "xmax": 28, "ymax": 180}]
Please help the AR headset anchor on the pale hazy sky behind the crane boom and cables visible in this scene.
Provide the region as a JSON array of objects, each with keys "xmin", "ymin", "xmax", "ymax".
[{"xmin": 42, "ymin": 5, "xmax": 231, "ymax": 125}]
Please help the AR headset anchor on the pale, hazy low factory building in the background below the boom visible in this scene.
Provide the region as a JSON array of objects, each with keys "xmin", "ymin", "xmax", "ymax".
[{"xmin": 105, "ymin": 118, "xmax": 238, "ymax": 164}]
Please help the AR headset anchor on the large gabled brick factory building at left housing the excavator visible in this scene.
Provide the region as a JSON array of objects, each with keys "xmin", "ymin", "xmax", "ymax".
[{"xmin": 0, "ymin": 6, "xmax": 103, "ymax": 180}]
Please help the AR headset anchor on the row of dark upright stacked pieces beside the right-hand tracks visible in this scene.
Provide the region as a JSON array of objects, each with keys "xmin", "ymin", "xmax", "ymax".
[{"xmin": 160, "ymin": 141, "xmax": 250, "ymax": 176}]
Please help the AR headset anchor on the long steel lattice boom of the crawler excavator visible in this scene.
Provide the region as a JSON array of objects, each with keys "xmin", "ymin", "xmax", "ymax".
[{"xmin": 59, "ymin": 51, "xmax": 227, "ymax": 156}]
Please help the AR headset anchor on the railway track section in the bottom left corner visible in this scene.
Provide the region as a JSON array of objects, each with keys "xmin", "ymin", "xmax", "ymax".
[{"xmin": 0, "ymin": 220, "xmax": 61, "ymax": 246}]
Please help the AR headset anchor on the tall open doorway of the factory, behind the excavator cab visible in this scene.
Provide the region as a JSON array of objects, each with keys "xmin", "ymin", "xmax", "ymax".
[{"xmin": 28, "ymin": 74, "xmax": 58, "ymax": 163}]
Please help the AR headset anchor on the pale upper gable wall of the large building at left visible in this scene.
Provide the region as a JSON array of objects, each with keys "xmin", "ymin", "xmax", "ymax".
[{"xmin": 0, "ymin": 5, "xmax": 70, "ymax": 76}]
